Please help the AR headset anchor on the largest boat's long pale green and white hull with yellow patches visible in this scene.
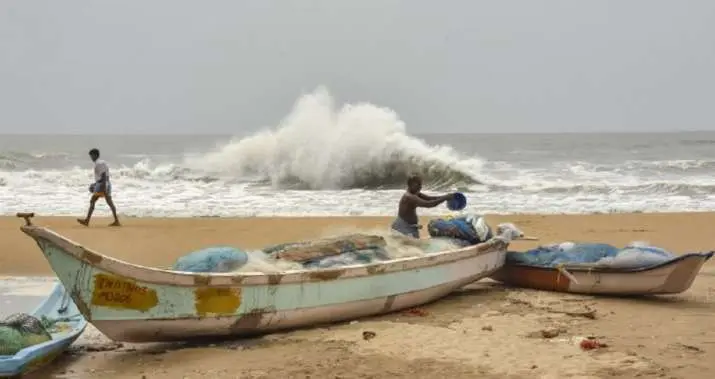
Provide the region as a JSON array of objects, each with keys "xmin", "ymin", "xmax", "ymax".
[{"xmin": 18, "ymin": 213, "xmax": 509, "ymax": 342}]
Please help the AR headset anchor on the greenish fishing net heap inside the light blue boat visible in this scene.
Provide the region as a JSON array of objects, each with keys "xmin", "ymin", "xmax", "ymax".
[{"xmin": 0, "ymin": 313, "xmax": 52, "ymax": 355}]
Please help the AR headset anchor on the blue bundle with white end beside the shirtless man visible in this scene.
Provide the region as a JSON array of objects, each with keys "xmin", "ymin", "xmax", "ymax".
[{"xmin": 427, "ymin": 214, "xmax": 492, "ymax": 244}]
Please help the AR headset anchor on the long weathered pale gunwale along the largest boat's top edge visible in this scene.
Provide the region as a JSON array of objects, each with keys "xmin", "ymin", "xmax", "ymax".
[{"xmin": 21, "ymin": 225, "xmax": 509, "ymax": 287}]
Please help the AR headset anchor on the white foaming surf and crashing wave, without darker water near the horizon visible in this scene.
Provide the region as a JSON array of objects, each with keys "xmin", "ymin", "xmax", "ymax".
[{"xmin": 0, "ymin": 88, "xmax": 715, "ymax": 216}]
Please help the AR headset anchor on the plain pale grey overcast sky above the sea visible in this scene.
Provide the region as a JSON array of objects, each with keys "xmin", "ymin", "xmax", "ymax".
[{"xmin": 0, "ymin": 0, "xmax": 715, "ymax": 134}]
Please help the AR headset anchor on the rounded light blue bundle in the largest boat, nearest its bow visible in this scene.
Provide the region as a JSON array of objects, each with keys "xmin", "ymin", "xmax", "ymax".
[{"xmin": 171, "ymin": 246, "xmax": 248, "ymax": 272}]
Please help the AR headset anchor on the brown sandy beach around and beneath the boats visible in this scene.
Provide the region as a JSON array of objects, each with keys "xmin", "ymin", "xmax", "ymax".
[{"xmin": 0, "ymin": 213, "xmax": 715, "ymax": 379}]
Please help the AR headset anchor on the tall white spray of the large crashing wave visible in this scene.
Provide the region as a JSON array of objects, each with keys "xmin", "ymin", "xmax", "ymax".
[{"xmin": 186, "ymin": 87, "xmax": 482, "ymax": 190}]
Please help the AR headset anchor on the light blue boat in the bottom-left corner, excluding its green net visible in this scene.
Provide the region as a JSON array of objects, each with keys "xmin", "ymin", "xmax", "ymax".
[{"xmin": 0, "ymin": 283, "xmax": 87, "ymax": 377}]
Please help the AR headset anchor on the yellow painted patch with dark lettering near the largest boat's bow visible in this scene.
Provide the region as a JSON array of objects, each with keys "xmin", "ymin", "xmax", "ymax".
[{"xmin": 92, "ymin": 274, "xmax": 159, "ymax": 312}]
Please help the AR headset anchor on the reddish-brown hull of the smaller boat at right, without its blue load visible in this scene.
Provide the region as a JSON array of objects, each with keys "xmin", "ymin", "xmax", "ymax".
[{"xmin": 491, "ymin": 255, "xmax": 710, "ymax": 295}]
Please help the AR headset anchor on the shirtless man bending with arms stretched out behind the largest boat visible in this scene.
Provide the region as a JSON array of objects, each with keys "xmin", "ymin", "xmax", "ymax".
[{"xmin": 392, "ymin": 175, "xmax": 454, "ymax": 238}]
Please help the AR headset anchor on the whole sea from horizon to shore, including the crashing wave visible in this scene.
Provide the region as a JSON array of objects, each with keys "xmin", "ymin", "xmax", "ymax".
[{"xmin": 0, "ymin": 91, "xmax": 715, "ymax": 217}]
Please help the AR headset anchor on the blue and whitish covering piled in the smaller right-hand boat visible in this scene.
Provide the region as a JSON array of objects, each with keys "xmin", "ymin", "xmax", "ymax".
[{"xmin": 506, "ymin": 242, "xmax": 675, "ymax": 268}]
